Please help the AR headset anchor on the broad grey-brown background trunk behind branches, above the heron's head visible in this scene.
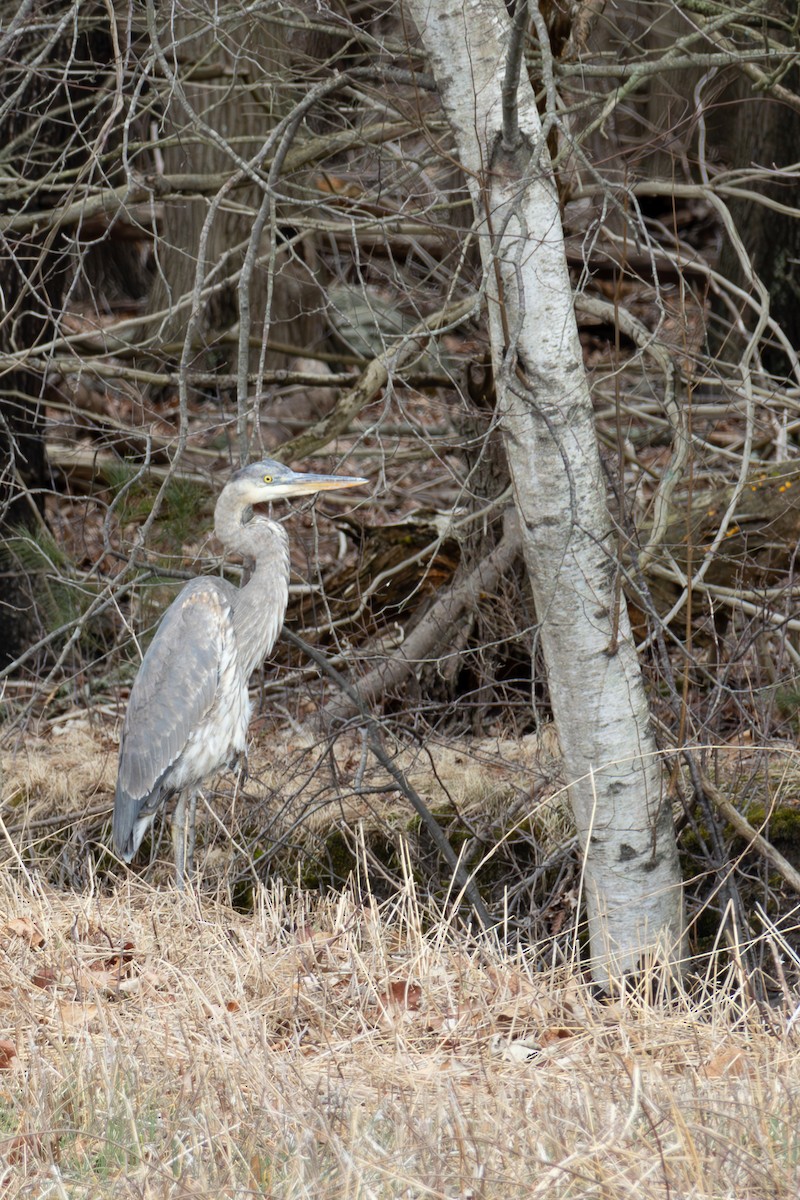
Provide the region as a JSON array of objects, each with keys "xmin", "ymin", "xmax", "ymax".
[{"xmin": 149, "ymin": 7, "xmax": 323, "ymax": 396}]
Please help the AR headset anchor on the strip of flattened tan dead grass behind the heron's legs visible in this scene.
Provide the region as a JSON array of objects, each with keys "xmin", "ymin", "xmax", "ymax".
[{"xmin": 0, "ymin": 710, "xmax": 573, "ymax": 890}]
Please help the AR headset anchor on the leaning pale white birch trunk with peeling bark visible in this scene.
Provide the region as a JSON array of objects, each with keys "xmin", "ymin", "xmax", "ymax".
[{"xmin": 409, "ymin": 0, "xmax": 684, "ymax": 983}]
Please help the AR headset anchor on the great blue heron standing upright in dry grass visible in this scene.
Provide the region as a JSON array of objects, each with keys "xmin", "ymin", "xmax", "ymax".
[{"xmin": 113, "ymin": 458, "xmax": 367, "ymax": 887}]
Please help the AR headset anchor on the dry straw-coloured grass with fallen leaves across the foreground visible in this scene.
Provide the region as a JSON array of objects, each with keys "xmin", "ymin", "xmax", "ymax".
[{"xmin": 0, "ymin": 864, "xmax": 800, "ymax": 1200}]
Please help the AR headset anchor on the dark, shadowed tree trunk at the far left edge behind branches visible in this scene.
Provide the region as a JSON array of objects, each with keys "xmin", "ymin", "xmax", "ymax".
[{"xmin": 0, "ymin": 0, "xmax": 110, "ymax": 667}]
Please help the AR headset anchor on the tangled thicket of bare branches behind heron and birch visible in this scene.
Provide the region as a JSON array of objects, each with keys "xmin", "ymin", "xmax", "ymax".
[{"xmin": 0, "ymin": 0, "xmax": 800, "ymax": 955}]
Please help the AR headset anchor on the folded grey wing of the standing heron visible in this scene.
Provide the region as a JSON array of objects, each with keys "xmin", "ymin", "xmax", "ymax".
[{"xmin": 116, "ymin": 578, "xmax": 235, "ymax": 806}]
